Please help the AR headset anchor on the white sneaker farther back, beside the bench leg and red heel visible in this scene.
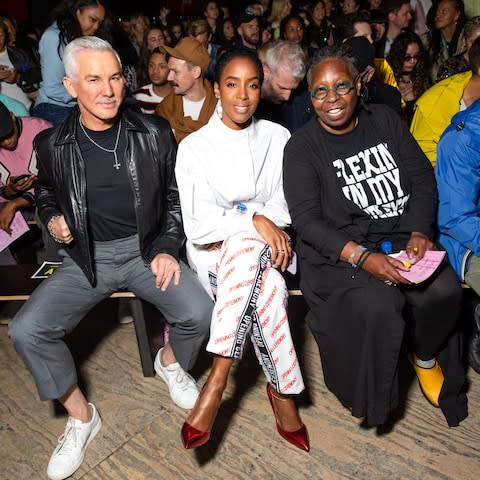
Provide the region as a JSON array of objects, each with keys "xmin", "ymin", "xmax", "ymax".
[{"xmin": 153, "ymin": 348, "xmax": 199, "ymax": 410}]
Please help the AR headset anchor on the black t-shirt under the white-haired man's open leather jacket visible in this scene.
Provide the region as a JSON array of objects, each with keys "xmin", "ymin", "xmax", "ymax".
[{"xmin": 78, "ymin": 118, "xmax": 137, "ymax": 241}]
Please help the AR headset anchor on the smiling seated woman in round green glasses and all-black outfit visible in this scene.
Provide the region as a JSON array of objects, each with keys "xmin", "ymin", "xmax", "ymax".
[{"xmin": 284, "ymin": 47, "xmax": 467, "ymax": 426}]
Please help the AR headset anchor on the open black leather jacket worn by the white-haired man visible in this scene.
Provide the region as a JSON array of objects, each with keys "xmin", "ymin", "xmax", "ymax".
[{"xmin": 33, "ymin": 108, "xmax": 184, "ymax": 285}]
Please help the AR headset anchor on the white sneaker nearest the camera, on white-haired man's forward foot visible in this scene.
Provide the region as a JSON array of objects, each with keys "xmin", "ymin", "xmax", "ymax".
[{"xmin": 47, "ymin": 403, "xmax": 102, "ymax": 480}]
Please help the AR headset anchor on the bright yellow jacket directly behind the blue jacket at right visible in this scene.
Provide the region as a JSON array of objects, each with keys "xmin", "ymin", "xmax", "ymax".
[{"xmin": 410, "ymin": 71, "xmax": 472, "ymax": 167}]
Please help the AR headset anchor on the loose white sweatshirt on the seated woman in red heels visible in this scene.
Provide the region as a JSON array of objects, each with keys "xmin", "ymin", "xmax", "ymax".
[{"xmin": 175, "ymin": 107, "xmax": 290, "ymax": 293}]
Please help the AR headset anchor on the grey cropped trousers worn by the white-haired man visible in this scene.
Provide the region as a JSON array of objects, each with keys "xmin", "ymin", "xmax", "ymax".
[{"xmin": 8, "ymin": 235, "xmax": 213, "ymax": 400}]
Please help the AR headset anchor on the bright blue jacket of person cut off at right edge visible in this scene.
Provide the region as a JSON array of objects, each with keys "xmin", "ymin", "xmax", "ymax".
[{"xmin": 436, "ymin": 100, "xmax": 480, "ymax": 281}]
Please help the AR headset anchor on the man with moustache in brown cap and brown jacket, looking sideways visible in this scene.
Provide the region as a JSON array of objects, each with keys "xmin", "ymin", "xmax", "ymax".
[{"xmin": 155, "ymin": 37, "xmax": 217, "ymax": 143}]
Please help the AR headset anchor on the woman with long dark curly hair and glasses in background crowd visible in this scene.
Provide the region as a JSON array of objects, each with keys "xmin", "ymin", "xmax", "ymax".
[{"xmin": 387, "ymin": 31, "xmax": 431, "ymax": 125}]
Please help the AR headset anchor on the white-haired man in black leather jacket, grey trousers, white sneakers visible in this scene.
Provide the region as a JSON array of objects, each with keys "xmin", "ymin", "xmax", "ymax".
[{"xmin": 9, "ymin": 37, "xmax": 213, "ymax": 480}]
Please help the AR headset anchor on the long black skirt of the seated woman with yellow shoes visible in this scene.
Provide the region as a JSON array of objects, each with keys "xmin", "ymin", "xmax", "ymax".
[{"xmin": 300, "ymin": 262, "xmax": 468, "ymax": 426}]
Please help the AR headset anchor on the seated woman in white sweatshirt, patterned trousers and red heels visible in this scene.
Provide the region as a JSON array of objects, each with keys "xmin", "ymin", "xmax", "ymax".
[{"xmin": 176, "ymin": 49, "xmax": 309, "ymax": 451}]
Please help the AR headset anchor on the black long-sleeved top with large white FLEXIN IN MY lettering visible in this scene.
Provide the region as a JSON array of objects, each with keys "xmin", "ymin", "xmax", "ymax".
[{"xmin": 283, "ymin": 105, "xmax": 437, "ymax": 264}]
